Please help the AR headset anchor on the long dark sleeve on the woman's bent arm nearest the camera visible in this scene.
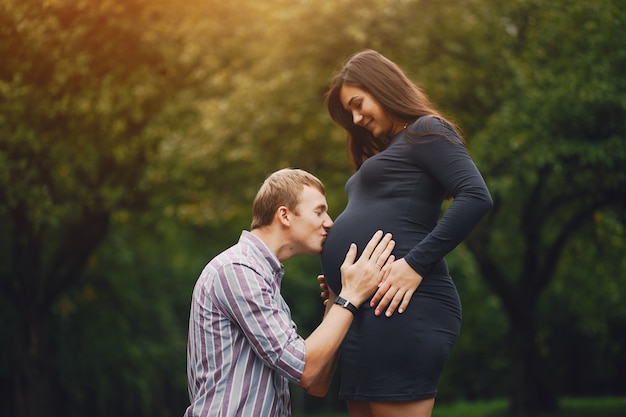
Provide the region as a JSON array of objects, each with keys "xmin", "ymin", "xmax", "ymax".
[{"xmin": 405, "ymin": 117, "xmax": 493, "ymax": 276}]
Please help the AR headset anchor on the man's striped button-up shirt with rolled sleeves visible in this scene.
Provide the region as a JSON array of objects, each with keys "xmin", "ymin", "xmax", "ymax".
[{"xmin": 185, "ymin": 230, "xmax": 305, "ymax": 417}]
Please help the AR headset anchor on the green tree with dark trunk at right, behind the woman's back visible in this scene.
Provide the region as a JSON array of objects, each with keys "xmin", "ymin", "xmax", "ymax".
[{"xmin": 468, "ymin": 0, "xmax": 626, "ymax": 416}]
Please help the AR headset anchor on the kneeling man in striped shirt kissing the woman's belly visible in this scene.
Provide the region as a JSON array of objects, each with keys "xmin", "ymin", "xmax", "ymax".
[{"xmin": 185, "ymin": 169, "xmax": 394, "ymax": 417}]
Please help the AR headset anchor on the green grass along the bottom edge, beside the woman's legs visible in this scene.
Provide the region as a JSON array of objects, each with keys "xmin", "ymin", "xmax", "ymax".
[{"xmin": 294, "ymin": 397, "xmax": 626, "ymax": 417}]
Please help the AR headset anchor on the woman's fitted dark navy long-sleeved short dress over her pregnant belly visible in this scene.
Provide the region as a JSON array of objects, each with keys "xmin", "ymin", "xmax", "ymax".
[{"xmin": 322, "ymin": 116, "xmax": 492, "ymax": 401}]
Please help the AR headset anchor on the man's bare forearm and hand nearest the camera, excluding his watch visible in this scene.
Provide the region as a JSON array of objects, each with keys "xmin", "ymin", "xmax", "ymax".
[{"xmin": 300, "ymin": 231, "xmax": 395, "ymax": 397}]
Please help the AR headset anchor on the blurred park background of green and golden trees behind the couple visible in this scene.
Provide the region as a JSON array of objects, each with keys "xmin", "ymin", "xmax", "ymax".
[{"xmin": 0, "ymin": 0, "xmax": 626, "ymax": 417}]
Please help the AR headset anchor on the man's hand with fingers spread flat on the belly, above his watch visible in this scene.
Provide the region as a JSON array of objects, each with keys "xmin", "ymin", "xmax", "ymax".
[{"xmin": 340, "ymin": 230, "xmax": 395, "ymax": 307}]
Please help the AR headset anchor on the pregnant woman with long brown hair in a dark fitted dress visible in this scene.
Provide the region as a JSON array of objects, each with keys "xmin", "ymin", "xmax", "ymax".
[{"xmin": 322, "ymin": 50, "xmax": 492, "ymax": 417}]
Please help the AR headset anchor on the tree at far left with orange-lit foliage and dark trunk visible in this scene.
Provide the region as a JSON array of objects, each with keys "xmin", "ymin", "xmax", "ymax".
[{"xmin": 0, "ymin": 0, "xmax": 197, "ymax": 416}]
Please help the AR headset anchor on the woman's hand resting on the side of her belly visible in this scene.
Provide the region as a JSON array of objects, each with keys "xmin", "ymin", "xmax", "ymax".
[{"xmin": 370, "ymin": 258, "xmax": 423, "ymax": 317}]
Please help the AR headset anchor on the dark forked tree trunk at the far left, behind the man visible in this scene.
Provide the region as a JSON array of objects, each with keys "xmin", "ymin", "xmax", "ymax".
[{"xmin": 4, "ymin": 207, "xmax": 110, "ymax": 417}]
